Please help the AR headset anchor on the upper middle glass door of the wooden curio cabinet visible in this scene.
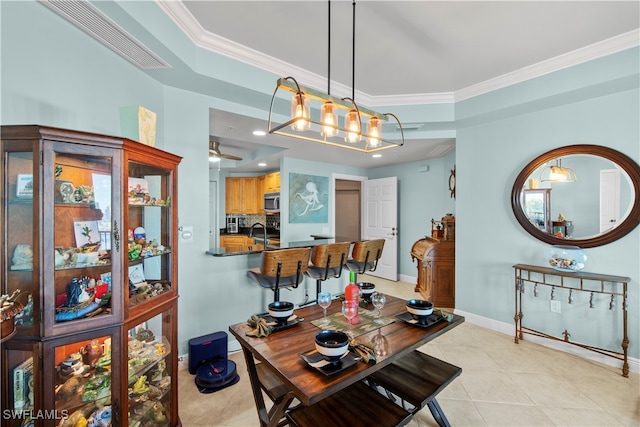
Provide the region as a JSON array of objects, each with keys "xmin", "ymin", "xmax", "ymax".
[{"xmin": 43, "ymin": 142, "xmax": 121, "ymax": 335}]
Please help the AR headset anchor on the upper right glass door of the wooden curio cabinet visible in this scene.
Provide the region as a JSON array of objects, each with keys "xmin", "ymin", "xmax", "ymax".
[{"xmin": 125, "ymin": 159, "xmax": 176, "ymax": 317}]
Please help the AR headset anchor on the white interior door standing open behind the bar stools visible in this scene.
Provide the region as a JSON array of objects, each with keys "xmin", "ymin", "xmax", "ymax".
[{"xmin": 362, "ymin": 176, "xmax": 398, "ymax": 281}]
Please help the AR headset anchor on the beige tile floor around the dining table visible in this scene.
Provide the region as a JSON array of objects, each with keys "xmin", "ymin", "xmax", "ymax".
[{"xmin": 178, "ymin": 276, "xmax": 640, "ymax": 427}]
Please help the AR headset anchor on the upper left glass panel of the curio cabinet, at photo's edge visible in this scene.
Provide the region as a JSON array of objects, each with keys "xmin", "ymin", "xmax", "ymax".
[{"xmin": 0, "ymin": 141, "xmax": 40, "ymax": 340}]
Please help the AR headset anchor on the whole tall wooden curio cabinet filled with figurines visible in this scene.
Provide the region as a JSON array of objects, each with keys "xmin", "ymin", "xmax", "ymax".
[{"xmin": 0, "ymin": 125, "xmax": 180, "ymax": 426}]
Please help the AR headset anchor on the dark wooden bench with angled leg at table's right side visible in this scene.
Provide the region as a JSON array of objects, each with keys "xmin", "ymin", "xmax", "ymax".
[{"xmin": 367, "ymin": 350, "xmax": 462, "ymax": 427}]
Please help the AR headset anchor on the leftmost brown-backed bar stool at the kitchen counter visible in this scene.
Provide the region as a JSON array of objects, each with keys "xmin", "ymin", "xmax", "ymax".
[{"xmin": 247, "ymin": 248, "xmax": 311, "ymax": 302}]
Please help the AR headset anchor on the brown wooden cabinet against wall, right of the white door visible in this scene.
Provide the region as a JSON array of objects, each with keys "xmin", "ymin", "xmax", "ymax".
[{"xmin": 411, "ymin": 237, "xmax": 456, "ymax": 308}]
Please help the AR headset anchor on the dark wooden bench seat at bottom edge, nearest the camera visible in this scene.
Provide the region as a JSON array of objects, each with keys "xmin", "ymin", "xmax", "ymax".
[{"xmin": 287, "ymin": 381, "xmax": 411, "ymax": 427}]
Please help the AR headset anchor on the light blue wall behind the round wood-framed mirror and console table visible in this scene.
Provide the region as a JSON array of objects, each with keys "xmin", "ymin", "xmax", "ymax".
[{"xmin": 456, "ymin": 49, "xmax": 640, "ymax": 357}]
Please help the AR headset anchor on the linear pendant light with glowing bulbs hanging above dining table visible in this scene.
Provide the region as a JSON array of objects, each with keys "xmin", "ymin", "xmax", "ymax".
[{"xmin": 269, "ymin": 1, "xmax": 404, "ymax": 153}]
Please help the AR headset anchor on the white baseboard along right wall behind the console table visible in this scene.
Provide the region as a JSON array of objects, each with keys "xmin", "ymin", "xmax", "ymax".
[{"xmin": 454, "ymin": 309, "xmax": 640, "ymax": 374}]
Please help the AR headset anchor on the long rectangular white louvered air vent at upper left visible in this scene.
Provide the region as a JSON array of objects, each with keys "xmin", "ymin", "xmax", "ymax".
[{"xmin": 40, "ymin": 0, "xmax": 171, "ymax": 70}]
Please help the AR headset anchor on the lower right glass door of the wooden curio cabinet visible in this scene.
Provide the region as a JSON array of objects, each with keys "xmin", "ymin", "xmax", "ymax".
[{"xmin": 126, "ymin": 304, "xmax": 177, "ymax": 427}]
